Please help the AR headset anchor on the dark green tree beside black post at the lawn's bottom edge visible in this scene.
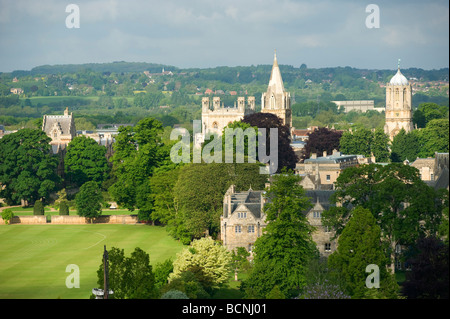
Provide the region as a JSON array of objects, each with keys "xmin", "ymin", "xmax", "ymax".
[{"xmin": 97, "ymin": 247, "xmax": 158, "ymax": 299}]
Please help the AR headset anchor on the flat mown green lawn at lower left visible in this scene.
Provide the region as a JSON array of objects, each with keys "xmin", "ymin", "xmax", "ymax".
[{"xmin": 0, "ymin": 224, "xmax": 183, "ymax": 299}]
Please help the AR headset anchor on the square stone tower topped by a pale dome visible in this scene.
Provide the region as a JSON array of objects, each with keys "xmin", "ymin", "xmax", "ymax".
[{"xmin": 384, "ymin": 60, "xmax": 413, "ymax": 141}]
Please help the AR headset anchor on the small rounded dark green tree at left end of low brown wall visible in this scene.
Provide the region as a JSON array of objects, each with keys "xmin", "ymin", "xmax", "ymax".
[{"xmin": 75, "ymin": 181, "xmax": 103, "ymax": 221}]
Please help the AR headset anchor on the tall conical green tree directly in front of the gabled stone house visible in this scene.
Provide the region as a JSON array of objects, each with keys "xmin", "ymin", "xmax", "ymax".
[{"xmin": 243, "ymin": 170, "xmax": 317, "ymax": 298}]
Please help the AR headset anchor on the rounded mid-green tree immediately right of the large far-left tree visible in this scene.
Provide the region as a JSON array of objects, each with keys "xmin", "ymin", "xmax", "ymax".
[{"xmin": 64, "ymin": 136, "xmax": 109, "ymax": 186}]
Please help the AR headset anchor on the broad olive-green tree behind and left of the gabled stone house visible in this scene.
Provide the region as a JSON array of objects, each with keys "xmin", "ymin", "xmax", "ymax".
[{"xmin": 169, "ymin": 163, "xmax": 267, "ymax": 239}]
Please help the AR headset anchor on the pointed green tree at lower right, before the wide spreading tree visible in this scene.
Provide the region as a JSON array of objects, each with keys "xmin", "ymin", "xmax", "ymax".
[{"xmin": 328, "ymin": 206, "xmax": 398, "ymax": 299}]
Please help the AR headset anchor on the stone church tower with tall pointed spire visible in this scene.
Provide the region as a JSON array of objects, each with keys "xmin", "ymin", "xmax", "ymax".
[{"xmin": 261, "ymin": 52, "xmax": 292, "ymax": 131}]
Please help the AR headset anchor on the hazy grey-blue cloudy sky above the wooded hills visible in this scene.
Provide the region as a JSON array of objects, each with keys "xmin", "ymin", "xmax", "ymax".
[{"xmin": 0, "ymin": 0, "xmax": 449, "ymax": 72}]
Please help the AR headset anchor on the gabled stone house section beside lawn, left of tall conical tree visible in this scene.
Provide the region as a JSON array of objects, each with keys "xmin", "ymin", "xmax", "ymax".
[{"xmin": 220, "ymin": 185, "xmax": 266, "ymax": 252}]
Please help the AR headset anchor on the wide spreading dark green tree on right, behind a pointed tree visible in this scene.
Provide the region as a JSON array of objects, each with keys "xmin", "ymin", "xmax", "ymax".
[{"xmin": 322, "ymin": 163, "xmax": 442, "ymax": 272}]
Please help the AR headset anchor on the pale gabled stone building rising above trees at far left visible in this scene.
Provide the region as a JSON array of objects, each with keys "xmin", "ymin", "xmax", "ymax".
[{"xmin": 42, "ymin": 108, "xmax": 77, "ymax": 154}]
